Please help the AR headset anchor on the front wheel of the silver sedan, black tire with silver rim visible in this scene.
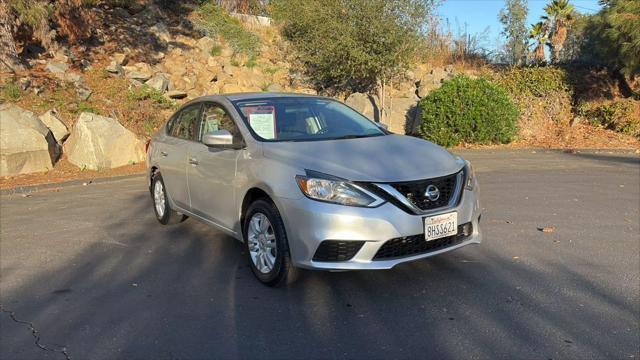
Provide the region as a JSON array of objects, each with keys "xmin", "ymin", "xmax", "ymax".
[{"xmin": 242, "ymin": 199, "xmax": 299, "ymax": 287}]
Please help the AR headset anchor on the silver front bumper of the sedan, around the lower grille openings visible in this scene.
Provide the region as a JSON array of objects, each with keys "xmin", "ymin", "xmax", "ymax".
[{"xmin": 276, "ymin": 187, "xmax": 482, "ymax": 270}]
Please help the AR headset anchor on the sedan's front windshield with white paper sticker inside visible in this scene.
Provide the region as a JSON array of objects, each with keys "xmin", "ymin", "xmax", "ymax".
[{"xmin": 234, "ymin": 97, "xmax": 385, "ymax": 141}]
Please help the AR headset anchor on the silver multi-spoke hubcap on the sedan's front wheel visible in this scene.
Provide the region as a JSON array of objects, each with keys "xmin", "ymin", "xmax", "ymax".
[{"xmin": 247, "ymin": 213, "xmax": 277, "ymax": 274}]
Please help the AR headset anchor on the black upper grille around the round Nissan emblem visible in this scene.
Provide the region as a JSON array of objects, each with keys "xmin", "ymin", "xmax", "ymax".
[{"xmin": 389, "ymin": 173, "xmax": 458, "ymax": 210}]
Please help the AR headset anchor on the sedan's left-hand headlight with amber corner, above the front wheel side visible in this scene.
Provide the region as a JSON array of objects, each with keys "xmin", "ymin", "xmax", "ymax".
[{"xmin": 296, "ymin": 171, "xmax": 384, "ymax": 207}]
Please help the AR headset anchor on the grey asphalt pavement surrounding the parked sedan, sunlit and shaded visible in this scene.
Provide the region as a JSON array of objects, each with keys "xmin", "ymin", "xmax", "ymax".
[{"xmin": 0, "ymin": 150, "xmax": 640, "ymax": 359}]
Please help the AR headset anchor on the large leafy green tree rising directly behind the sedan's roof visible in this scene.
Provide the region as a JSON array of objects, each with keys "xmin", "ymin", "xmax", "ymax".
[{"xmin": 272, "ymin": 0, "xmax": 433, "ymax": 93}]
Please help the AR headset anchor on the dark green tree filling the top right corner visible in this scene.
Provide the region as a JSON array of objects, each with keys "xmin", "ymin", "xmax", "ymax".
[{"xmin": 580, "ymin": 0, "xmax": 640, "ymax": 77}]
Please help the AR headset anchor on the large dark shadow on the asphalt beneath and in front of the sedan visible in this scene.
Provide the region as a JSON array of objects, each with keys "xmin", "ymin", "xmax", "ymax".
[{"xmin": 2, "ymin": 186, "xmax": 638, "ymax": 359}]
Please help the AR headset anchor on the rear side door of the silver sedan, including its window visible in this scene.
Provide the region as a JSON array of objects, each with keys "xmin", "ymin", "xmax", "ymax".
[{"xmin": 160, "ymin": 103, "xmax": 201, "ymax": 210}]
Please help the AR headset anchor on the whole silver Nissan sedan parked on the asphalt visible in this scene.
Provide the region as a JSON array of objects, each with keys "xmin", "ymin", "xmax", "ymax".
[{"xmin": 147, "ymin": 93, "xmax": 482, "ymax": 286}]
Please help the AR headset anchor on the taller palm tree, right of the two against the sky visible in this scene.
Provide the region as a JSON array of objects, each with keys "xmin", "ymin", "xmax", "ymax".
[{"xmin": 542, "ymin": 0, "xmax": 575, "ymax": 62}]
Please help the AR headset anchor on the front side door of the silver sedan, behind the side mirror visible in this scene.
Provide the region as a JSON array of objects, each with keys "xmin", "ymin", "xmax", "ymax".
[{"xmin": 187, "ymin": 102, "xmax": 245, "ymax": 230}]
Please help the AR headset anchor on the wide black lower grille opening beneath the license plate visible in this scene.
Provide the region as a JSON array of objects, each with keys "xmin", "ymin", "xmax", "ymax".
[{"xmin": 373, "ymin": 223, "xmax": 473, "ymax": 260}]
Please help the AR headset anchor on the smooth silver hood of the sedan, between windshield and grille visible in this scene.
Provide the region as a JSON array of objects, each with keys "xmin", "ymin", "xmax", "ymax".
[{"xmin": 263, "ymin": 135, "xmax": 463, "ymax": 182}]
